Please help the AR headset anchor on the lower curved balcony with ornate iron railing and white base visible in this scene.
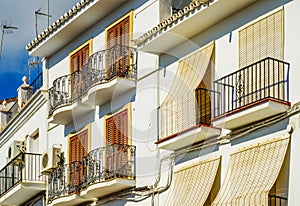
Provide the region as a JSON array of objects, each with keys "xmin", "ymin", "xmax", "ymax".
[{"xmin": 48, "ymin": 144, "xmax": 135, "ymax": 205}]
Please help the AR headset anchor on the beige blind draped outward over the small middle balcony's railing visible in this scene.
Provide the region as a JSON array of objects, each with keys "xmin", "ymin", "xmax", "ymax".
[{"xmin": 160, "ymin": 43, "xmax": 214, "ymax": 137}]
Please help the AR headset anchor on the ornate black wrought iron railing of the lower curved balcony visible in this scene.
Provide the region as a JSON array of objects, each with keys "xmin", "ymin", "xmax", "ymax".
[{"xmin": 48, "ymin": 144, "xmax": 135, "ymax": 202}]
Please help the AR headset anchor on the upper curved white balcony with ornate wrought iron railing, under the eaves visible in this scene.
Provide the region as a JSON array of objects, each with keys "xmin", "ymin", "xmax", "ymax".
[{"xmin": 49, "ymin": 45, "xmax": 137, "ymax": 124}]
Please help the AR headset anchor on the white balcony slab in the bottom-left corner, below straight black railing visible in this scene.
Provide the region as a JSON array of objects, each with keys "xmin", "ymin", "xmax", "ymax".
[{"xmin": 0, "ymin": 181, "xmax": 47, "ymax": 205}]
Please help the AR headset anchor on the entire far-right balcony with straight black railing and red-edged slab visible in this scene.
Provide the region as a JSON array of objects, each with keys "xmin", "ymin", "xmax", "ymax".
[{"xmin": 213, "ymin": 57, "xmax": 290, "ymax": 129}]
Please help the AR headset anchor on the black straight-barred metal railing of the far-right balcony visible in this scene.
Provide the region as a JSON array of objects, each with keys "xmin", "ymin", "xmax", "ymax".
[{"xmin": 214, "ymin": 57, "xmax": 290, "ymax": 117}]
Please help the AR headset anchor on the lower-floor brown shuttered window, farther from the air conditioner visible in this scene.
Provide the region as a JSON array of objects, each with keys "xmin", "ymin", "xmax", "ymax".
[{"xmin": 106, "ymin": 109, "xmax": 128, "ymax": 177}]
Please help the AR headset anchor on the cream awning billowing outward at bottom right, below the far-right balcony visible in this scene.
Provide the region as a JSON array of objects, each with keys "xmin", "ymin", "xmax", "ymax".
[{"xmin": 212, "ymin": 137, "xmax": 289, "ymax": 206}]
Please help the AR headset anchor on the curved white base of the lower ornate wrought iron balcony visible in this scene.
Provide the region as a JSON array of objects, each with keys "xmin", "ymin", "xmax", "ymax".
[{"xmin": 48, "ymin": 178, "xmax": 135, "ymax": 206}]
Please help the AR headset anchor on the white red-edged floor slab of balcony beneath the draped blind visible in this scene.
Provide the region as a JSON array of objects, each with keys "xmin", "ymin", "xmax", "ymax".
[{"xmin": 157, "ymin": 125, "xmax": 221, "ymax": 150}]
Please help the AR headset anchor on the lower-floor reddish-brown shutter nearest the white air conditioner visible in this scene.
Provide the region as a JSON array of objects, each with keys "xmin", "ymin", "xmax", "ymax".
[{"xmin": 69, "ymin": 129, "xmax": 88, "ymax": 192}]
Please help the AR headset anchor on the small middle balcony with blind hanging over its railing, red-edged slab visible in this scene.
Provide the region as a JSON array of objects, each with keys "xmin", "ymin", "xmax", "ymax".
[{"xmin": 156, "ymin": 88, "xmax": 221, "ymax": 150}]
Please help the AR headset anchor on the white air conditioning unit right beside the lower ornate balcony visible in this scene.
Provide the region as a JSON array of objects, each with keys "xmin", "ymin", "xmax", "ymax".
[{"xmin": 41, "ymin": 147, "xmax": 61, "ymax": 174}]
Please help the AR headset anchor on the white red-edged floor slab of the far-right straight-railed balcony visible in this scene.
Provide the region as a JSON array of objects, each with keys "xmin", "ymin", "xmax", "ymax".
[{"xmin": 212, "ymin": 98, "xmax": 290, "ymax": 129}]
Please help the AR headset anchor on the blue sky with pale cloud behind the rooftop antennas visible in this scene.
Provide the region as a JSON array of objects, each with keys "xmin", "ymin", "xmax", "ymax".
[{"xmin": 0, "ymin": 0, "xmax": 80, "ymax": 100}]
